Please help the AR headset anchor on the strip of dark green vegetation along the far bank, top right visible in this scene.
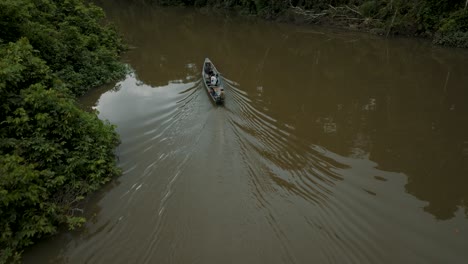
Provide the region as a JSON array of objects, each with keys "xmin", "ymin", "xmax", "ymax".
[{"xmin": 146, "ymin": 0, "xmax": 468, "ymax": 48}]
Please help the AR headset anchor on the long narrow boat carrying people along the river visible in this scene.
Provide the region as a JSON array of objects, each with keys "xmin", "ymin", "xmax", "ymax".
[{"xmin": 202, "ymin": 58, "xmax": 224, "ymax": 104}]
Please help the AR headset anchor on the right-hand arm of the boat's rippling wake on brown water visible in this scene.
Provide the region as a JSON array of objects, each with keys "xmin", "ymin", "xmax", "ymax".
[{"xmin": 218, "ymin": 75, "xmax": 396, "ymax": 263}]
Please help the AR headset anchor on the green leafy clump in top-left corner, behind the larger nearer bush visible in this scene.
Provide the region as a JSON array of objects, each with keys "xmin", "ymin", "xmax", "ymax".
[{"xmin": 0, "ymin": 0, "xmax": 125, "ymax": 95}]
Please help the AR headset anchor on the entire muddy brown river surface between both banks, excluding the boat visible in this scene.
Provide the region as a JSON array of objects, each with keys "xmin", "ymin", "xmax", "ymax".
[{"xmin": 24, "ymin": 1, "xmax": 468, "ymax": 264}]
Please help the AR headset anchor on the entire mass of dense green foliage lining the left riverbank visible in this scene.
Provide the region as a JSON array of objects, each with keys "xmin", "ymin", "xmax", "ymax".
[{"xmin": 0, "ymin": 0, "xmax": 125, "ymax": 263}]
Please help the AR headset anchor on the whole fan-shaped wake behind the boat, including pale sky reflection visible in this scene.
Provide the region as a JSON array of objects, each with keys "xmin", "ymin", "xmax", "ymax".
[{"xmin": 22, "ymin": 66, "xmax": 464, "ymax": 263}]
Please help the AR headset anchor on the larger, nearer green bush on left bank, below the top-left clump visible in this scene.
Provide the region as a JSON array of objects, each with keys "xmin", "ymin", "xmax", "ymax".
[{"xmin": 0, "ymin": 38, "xmax": 119, "ymax": 263}]
